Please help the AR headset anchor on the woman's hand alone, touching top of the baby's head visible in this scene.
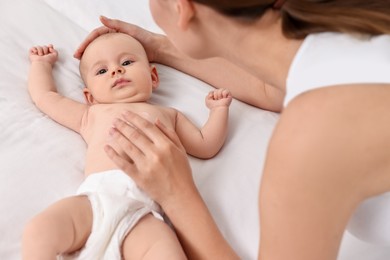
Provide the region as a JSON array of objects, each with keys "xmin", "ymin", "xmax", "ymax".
[{"xmin": 74, "ymin": 16, "xmax": 174, "ymax": 63}]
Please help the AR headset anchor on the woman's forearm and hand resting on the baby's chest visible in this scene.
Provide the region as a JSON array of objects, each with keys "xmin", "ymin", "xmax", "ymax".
[{"xmin": 105, "ymin": 112, "xmax": 238, "ymax": 259}]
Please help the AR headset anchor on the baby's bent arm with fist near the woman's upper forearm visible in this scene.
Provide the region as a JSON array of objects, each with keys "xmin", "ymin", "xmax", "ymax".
[{"xmin": 176, "ymin": 89, "xmax": 232, "ymax": 159}]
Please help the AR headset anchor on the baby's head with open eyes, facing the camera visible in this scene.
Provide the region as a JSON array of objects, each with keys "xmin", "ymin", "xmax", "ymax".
[{"xmin": 80, "ymin": 33, "xmax": 158, "ymax": 104}]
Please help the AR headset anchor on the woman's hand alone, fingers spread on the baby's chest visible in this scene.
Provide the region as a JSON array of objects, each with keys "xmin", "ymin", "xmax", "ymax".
[{"xmin": 105, "ymin": 112, "xmax": 196, "ymax": 208}]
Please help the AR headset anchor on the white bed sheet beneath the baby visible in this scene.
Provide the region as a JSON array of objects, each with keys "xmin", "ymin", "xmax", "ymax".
[{"xmin": 0, "ymin": 0, "xmax": 390, "ymax": 260}]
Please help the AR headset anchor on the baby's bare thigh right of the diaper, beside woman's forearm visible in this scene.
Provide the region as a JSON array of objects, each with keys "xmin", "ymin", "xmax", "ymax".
[{"xmin": 122, "ymin": 214, "xmax": 187, "ymax": 260}]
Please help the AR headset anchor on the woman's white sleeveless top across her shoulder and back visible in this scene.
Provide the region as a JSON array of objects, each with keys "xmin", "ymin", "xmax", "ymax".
[{"xmin": 284, "ymin": 33, "xmax": 390, "ymax": 106}]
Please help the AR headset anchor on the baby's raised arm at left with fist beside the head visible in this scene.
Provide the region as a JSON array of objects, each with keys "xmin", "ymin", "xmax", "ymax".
[{"xmin": 28, "ymin": 45, "xmax": 87, "ymax": 132}]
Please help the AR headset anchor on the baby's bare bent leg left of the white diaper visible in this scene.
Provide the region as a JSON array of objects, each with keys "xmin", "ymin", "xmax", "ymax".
[{"xmin": 22, "ymin": 196, "xmax": 92, "ymax": 260}]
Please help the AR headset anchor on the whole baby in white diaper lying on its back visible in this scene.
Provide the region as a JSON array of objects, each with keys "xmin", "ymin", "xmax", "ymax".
[{"xmin": 23, "ymin": 33, "xmax": 232, "ymax": 260}]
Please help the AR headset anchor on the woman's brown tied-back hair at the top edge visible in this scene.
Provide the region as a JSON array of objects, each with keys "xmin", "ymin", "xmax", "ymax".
[{"xmin": 193, "ymin": 0, "xmax": 390, "ymax": 38}]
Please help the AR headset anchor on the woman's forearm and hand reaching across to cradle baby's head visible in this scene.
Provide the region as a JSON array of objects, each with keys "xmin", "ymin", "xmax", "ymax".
[{"xmin": 74, "ymin": 17, "xmax": 284, "ymax": 112}]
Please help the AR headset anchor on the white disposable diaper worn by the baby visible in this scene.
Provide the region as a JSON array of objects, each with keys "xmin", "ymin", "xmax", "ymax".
[{"xmin": 66, "ymin": 170, "xmax": 163, "ymax": 260}]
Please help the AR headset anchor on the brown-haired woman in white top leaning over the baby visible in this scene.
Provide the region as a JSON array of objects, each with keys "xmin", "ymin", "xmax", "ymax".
[{"xmin": 75, "ymin": 0, "xmax": 390, "ymax": 260}]
